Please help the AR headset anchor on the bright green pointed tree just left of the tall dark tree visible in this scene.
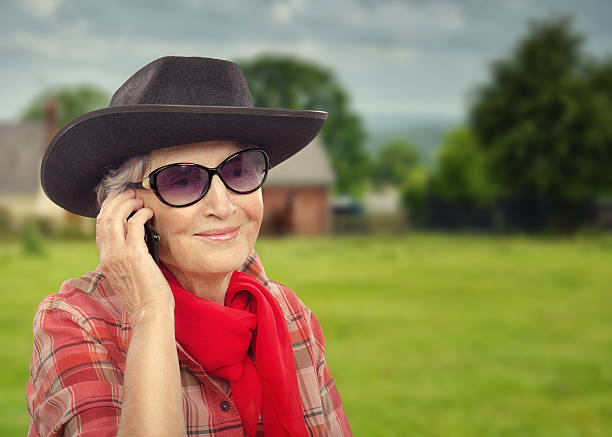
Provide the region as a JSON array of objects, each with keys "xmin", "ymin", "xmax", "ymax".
[{"xmin": 432, "ymin": 126, "xmax": 496, "ymax": 208}]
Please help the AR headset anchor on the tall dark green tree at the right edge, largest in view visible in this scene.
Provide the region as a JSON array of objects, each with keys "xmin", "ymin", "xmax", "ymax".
[{"xmin": 470, "ymin": 17, "xmax": 612, "ymax": 229}]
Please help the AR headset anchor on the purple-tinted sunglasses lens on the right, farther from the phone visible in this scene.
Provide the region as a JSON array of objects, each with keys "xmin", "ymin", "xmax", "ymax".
[{"xmin": 219, "ymin": 150, "xmax": 268, "ymax": 193}]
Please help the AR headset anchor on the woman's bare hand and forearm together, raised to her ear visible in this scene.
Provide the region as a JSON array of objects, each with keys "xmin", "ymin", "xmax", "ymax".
[{"xmin": 96, "ymin": 190, "xmax": 186, "ymax": 436}]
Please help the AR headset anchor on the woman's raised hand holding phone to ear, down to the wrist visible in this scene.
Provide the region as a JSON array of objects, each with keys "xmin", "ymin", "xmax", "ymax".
[{"xmin": 96, "ymin": 190, "xmax": 174, "ymax": 328}]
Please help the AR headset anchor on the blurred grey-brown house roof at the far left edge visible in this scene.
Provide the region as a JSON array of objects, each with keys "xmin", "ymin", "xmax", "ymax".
[{"xmin": 0, "ymin": 121, "xmax": 48, "ymax": 194}]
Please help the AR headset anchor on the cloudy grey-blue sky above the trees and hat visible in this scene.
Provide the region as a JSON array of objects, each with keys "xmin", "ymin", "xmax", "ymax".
[{"xmin": 0, "ymin": 0, "xmax": 612, "ymax": 127}]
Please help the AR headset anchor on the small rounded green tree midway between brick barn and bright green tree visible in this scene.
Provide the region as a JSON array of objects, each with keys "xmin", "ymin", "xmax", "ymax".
[{"xmin": 372, "ymin": 139, "xmax": 420, "ymax": 187}]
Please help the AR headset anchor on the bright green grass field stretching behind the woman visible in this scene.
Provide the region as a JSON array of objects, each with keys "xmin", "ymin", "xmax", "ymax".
[{"xmin": 0, "ymin": 234, "xmax": 612, "ymax": 437}]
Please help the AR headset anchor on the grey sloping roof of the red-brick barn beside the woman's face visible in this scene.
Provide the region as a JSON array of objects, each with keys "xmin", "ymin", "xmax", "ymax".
[{"xmin": 266, "ymin": 136, "xmax": 334, "ymax": 187}]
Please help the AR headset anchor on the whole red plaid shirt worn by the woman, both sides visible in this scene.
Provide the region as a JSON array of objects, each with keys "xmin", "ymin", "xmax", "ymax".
[{"xmin": 26, "ymin": 252, "xmax": 351, "ymax": 437}]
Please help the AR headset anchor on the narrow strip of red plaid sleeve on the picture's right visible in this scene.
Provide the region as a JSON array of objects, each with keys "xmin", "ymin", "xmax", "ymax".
[{"xmin": 310, "ymin": 312, "xmax": 353, "ymax": 436}]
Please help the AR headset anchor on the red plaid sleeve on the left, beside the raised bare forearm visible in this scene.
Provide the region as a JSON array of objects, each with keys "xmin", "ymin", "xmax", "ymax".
[{"xmin": 26, "ymin": 308, "xmax": 123, "ymax": 437}]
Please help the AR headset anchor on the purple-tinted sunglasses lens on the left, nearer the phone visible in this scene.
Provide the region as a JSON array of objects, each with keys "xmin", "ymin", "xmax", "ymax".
[{"xmin": 155, "ymin": 165, "xmax": 209, "ymax": 206}]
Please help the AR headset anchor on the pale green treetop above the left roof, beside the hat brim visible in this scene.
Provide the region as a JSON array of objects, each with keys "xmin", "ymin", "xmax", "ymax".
[{"xmin": 22, "ymin": 85, "xmax": 110, "ymax": 126}]
